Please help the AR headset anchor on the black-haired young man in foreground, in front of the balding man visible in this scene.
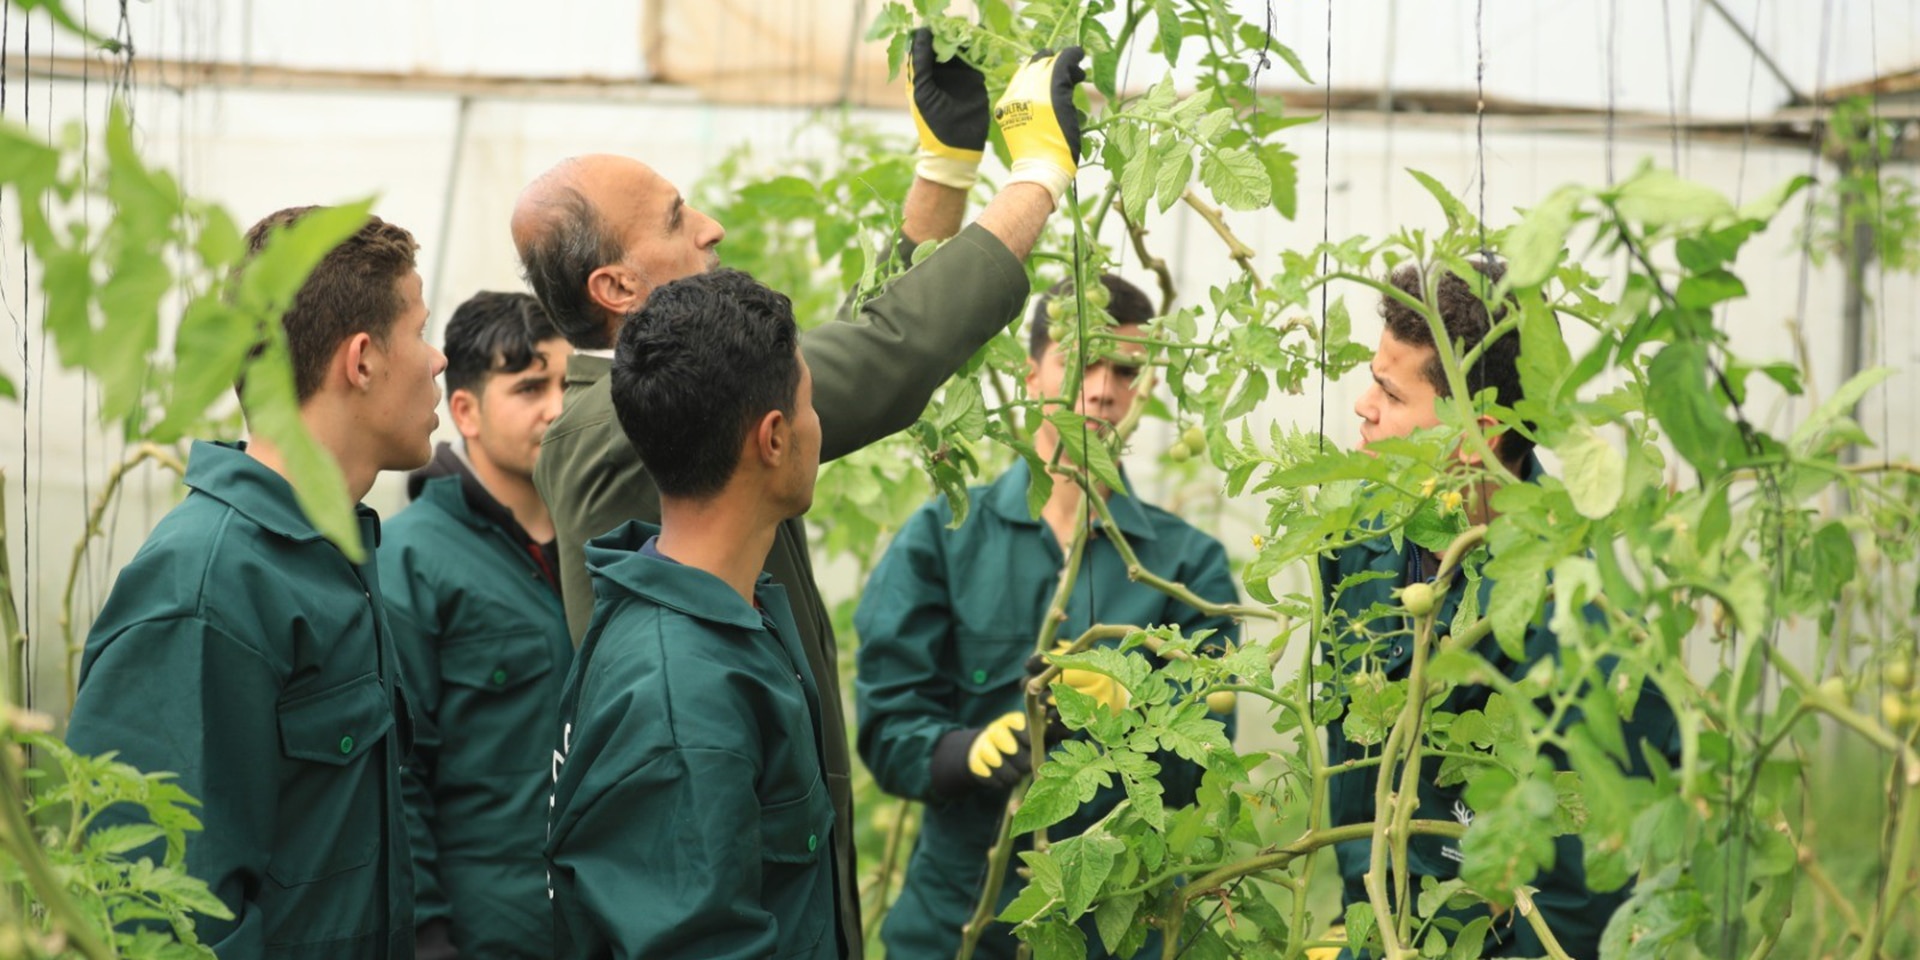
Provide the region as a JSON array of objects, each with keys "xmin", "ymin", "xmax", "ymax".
[{"xmin": 547, "ymin": 271, "xmax": 843, "ymax": 960}]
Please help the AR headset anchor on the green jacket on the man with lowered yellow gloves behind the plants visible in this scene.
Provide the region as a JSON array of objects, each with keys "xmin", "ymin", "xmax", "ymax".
[{"xmin": 854, "ymin": 463, "xmax": 1238, "ymax": 960}]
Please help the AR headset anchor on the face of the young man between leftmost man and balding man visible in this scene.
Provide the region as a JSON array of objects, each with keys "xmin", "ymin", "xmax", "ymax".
[{"xmin": 460, "ymin": 336, "xmax": 574, "ymax": 480}]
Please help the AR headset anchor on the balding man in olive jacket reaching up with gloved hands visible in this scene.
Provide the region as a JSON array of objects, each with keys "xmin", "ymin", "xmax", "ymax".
[{"xmin": 513, "ymin": 31, "xmax": 1085, "ymax": 956}]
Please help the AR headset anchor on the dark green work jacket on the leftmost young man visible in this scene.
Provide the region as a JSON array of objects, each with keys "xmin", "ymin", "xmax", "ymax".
[{"xmin": 67, "ymin": 444, "xmax": 413, "ymax": 960}]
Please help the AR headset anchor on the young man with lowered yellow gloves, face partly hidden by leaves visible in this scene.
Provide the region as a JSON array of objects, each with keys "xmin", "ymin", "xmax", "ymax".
[{"xmin": 854, "ymin": 276, "xmax": 1238, "ymax": 960}]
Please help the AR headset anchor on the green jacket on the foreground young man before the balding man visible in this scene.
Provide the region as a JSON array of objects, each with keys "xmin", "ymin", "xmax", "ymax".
[{"xmin": 547, "ymin": 522, "xmax": 841, "ymax": 960}]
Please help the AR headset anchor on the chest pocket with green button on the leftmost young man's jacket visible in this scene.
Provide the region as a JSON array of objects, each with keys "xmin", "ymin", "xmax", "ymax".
[{"xmin": 267, "ymin": 674, "xmax": 399, "ymax": 887}]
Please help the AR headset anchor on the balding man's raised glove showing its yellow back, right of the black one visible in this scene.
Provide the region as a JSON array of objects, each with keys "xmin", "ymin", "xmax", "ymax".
[{"xmin": 993, "ymin": 46, "xmax": 1087, "ymax": 205}]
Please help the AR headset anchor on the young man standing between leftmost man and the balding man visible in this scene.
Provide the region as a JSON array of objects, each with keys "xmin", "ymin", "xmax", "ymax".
[{"xmin": 380, "ymin": 292, "xmax": 574, "ymax": 960}]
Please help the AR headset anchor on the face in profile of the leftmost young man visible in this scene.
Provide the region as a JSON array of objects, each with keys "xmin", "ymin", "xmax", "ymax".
[{"xmin": 367, "ymin": 271, "xmax": 447, "ymax": 470}]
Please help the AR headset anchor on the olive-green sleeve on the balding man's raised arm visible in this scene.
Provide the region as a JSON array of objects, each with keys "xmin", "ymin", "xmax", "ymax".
[{"xmin": 801, "ymin": 225, "xmax": 1029, "ymax": 459}]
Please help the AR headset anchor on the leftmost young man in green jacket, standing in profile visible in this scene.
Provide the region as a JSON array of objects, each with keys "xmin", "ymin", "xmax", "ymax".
[{"xmin": 67, "ymin": 207, "xmax": 445, "ymax": 960}]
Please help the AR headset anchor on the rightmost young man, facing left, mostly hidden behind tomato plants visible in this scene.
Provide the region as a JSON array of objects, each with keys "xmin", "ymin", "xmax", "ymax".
[{"xmin": 1309, "ymin": 261, "xmax": 1678, "ymax": 958}]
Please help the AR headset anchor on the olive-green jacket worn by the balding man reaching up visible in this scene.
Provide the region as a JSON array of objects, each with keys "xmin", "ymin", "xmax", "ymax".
[{"xmin": 534, "ymin": 225, "xmax": 1027, "ymax": 958}]
